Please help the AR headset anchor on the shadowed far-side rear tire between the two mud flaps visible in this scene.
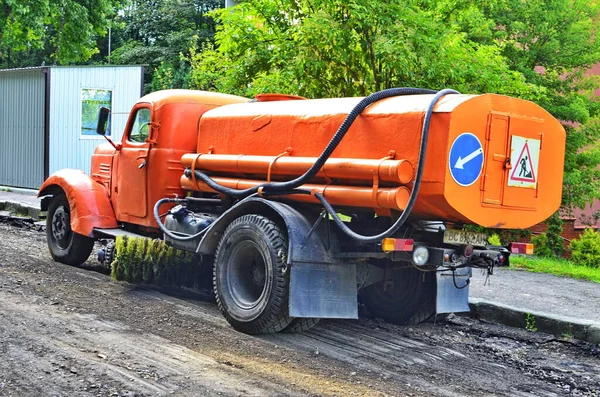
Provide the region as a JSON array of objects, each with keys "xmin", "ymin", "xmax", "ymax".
[{"xmin": 359, "ymin": 268, "xmax": 436, "ymax": 325}]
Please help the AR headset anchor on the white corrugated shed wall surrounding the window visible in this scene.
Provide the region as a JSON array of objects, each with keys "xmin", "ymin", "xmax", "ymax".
[{"xmin": 50, "ymin": 66, "xmax": 142, "ymax": 175}]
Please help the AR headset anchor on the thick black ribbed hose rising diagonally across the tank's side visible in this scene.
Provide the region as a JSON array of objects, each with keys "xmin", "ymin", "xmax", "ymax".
[{"xmin": 184, "ymin": 88, "xmax": 436, "ymax": 198}]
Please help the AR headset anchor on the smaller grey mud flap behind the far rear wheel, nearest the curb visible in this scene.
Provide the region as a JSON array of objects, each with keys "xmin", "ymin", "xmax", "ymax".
[{"xmin": 436, "ymin": 267, "xmax": 472, "ymax": 313}]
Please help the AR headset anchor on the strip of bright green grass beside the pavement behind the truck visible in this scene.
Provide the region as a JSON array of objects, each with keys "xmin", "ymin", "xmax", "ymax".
[{"xmin": 510, "ymin": 255, "xmax": 600, "ymax": 283}]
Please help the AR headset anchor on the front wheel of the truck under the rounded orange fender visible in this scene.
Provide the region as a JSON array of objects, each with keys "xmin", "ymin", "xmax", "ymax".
[{"xmin": 46, "ymin": 194, "xmax": 94, "ymax": 266}]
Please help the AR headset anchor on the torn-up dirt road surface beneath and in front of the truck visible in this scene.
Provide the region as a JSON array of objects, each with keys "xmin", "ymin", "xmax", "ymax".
[{"xmin": 0, "ymin": 224, "xmax": 600, "ymax": 396}]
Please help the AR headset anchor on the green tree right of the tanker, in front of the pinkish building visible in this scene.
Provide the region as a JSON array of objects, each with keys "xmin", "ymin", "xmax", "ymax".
[{"xmin": 450, "ymin": 0, "xmax": 600, "ymax": 211}]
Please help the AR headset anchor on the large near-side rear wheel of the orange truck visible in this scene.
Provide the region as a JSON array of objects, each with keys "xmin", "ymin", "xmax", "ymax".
[{"xmin": 213, "ymin": 215, "xmax": 292, "ymax": 335}]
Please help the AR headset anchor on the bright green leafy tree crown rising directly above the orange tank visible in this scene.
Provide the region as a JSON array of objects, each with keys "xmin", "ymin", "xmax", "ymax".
[{"xmin": 191, "ymin": 0, "xmax": 539, "ymax": 97}]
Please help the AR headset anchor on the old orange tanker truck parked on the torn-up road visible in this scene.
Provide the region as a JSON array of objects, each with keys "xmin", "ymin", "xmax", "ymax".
[{"xmin": 39, "ymin": 88, "xmax": 565, "ymax": 334}]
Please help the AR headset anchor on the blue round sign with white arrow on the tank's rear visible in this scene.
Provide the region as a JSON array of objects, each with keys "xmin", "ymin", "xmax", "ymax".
[{"xmin": 449, "ymin": 132, "xmax": 483, "ymax": 186}]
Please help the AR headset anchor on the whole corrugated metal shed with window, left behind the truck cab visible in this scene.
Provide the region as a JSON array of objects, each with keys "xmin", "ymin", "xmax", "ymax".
[{"xmin": 0, "ymin": 65, "xmax": 143, "ymax": 189}]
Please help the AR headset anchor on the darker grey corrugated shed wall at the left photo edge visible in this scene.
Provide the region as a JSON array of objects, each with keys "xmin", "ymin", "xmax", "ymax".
[{"xmin": 0, "ymin": 69, "xmax": 45, "ymax": 188}]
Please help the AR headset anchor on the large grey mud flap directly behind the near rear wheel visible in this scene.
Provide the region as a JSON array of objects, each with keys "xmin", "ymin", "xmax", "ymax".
[{"xmin": 290, "ymin": 263, "xmax": 358, "ymax": 319}]
